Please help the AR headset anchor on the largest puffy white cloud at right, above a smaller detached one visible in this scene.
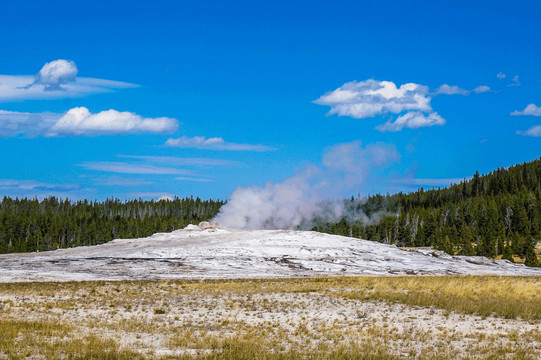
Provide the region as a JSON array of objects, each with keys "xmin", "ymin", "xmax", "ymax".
[{"xmin": 314, "ymin": 79, "xmax": 432, "ymax": 119}]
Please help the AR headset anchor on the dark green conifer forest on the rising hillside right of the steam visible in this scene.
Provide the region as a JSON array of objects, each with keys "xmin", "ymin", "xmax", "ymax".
[{"xmin": 313, "ymin": 158, "xmax": 541, "ymax": 266}]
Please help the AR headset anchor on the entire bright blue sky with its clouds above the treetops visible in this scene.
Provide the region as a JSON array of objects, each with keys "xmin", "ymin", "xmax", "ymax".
[{"xmin": 0, "ymin": 1, "xmax": 541, "ymax": 200}]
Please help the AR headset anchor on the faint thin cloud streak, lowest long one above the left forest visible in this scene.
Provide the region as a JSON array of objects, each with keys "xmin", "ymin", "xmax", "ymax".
[{"xmin": 78, "ymin": 161, "xmax": 193, "ymax": 175}]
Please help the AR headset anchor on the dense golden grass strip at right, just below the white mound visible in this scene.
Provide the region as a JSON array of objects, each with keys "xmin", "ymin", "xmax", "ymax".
[{"xmin": 345, "ymin": 276, "xmax": 541, "ymax": 320}]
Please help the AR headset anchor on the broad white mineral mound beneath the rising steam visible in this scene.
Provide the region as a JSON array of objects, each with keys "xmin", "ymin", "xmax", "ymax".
[{"xmin": 0, "ymin": 222, "xmax": 541, "ymax": 282}]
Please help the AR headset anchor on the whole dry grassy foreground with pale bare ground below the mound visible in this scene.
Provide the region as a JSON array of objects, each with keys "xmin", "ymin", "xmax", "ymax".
[{"xmin": 0, "ymin": 276, "xmax": 541, "ymax": 359}]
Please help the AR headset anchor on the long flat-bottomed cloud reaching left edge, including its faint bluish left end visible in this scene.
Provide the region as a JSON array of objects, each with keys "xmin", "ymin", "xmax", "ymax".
[{"xmin": 0, "ymin": 107, "xmax": 179, "ymax": 137}]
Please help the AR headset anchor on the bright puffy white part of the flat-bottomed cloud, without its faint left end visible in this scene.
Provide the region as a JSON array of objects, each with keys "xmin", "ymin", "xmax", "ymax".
[{"xmin": 45, "ymin": 107, "xmax": 179, "ymax": 136}]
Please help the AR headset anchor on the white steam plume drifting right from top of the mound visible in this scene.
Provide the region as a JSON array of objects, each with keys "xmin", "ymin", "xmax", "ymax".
[{"xmin": 214, "ymin": 141, "xmax": 400, "ymax": 229}]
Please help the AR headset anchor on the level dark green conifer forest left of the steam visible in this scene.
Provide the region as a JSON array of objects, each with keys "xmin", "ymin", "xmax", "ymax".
[{"xmin": 0, "ymin": 197, "xmax": 224, "ymax": 253}]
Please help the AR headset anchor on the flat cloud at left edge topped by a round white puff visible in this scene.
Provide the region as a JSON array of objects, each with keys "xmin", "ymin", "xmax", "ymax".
[{"xmin": 0, "ymin": 59, "xmax": 138, "ymax": 101}]
